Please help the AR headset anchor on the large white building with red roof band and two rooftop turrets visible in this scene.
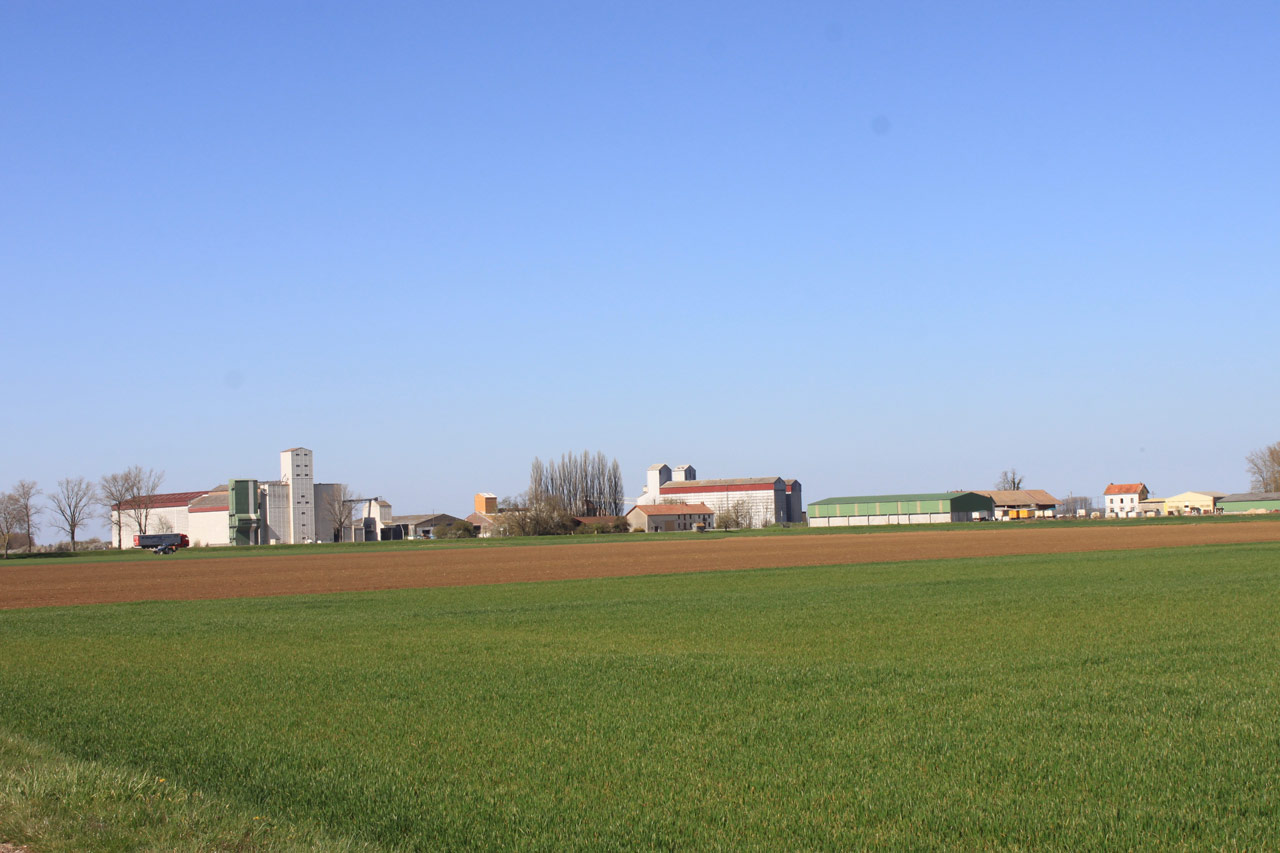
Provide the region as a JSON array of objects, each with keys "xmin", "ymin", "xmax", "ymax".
[{"xmin": 636, "ymin": 462, "xmax": 804, "ymax": 528}]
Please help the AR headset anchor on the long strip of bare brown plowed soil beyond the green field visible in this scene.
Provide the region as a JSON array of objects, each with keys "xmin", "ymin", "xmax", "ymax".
[{"xmin": 0, "ymin": 521, "xmax": 1280, "ymax": 608}]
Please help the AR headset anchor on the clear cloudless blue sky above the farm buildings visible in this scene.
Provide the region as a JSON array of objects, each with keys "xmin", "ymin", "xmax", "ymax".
[{"xmin": 0, "ymin": 0, "xmax": 1280, "ymax": 539}]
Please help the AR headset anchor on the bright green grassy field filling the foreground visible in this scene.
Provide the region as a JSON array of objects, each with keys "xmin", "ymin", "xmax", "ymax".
[{"xmin": 0, "ymin": 544, "xmax": 1280, "ymax": 853}]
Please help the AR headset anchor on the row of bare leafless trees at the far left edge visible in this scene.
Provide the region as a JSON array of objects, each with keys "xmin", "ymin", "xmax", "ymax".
[{"xmin": 0, "ymin": 465, "xmax": 164, "ymax": 558}]
